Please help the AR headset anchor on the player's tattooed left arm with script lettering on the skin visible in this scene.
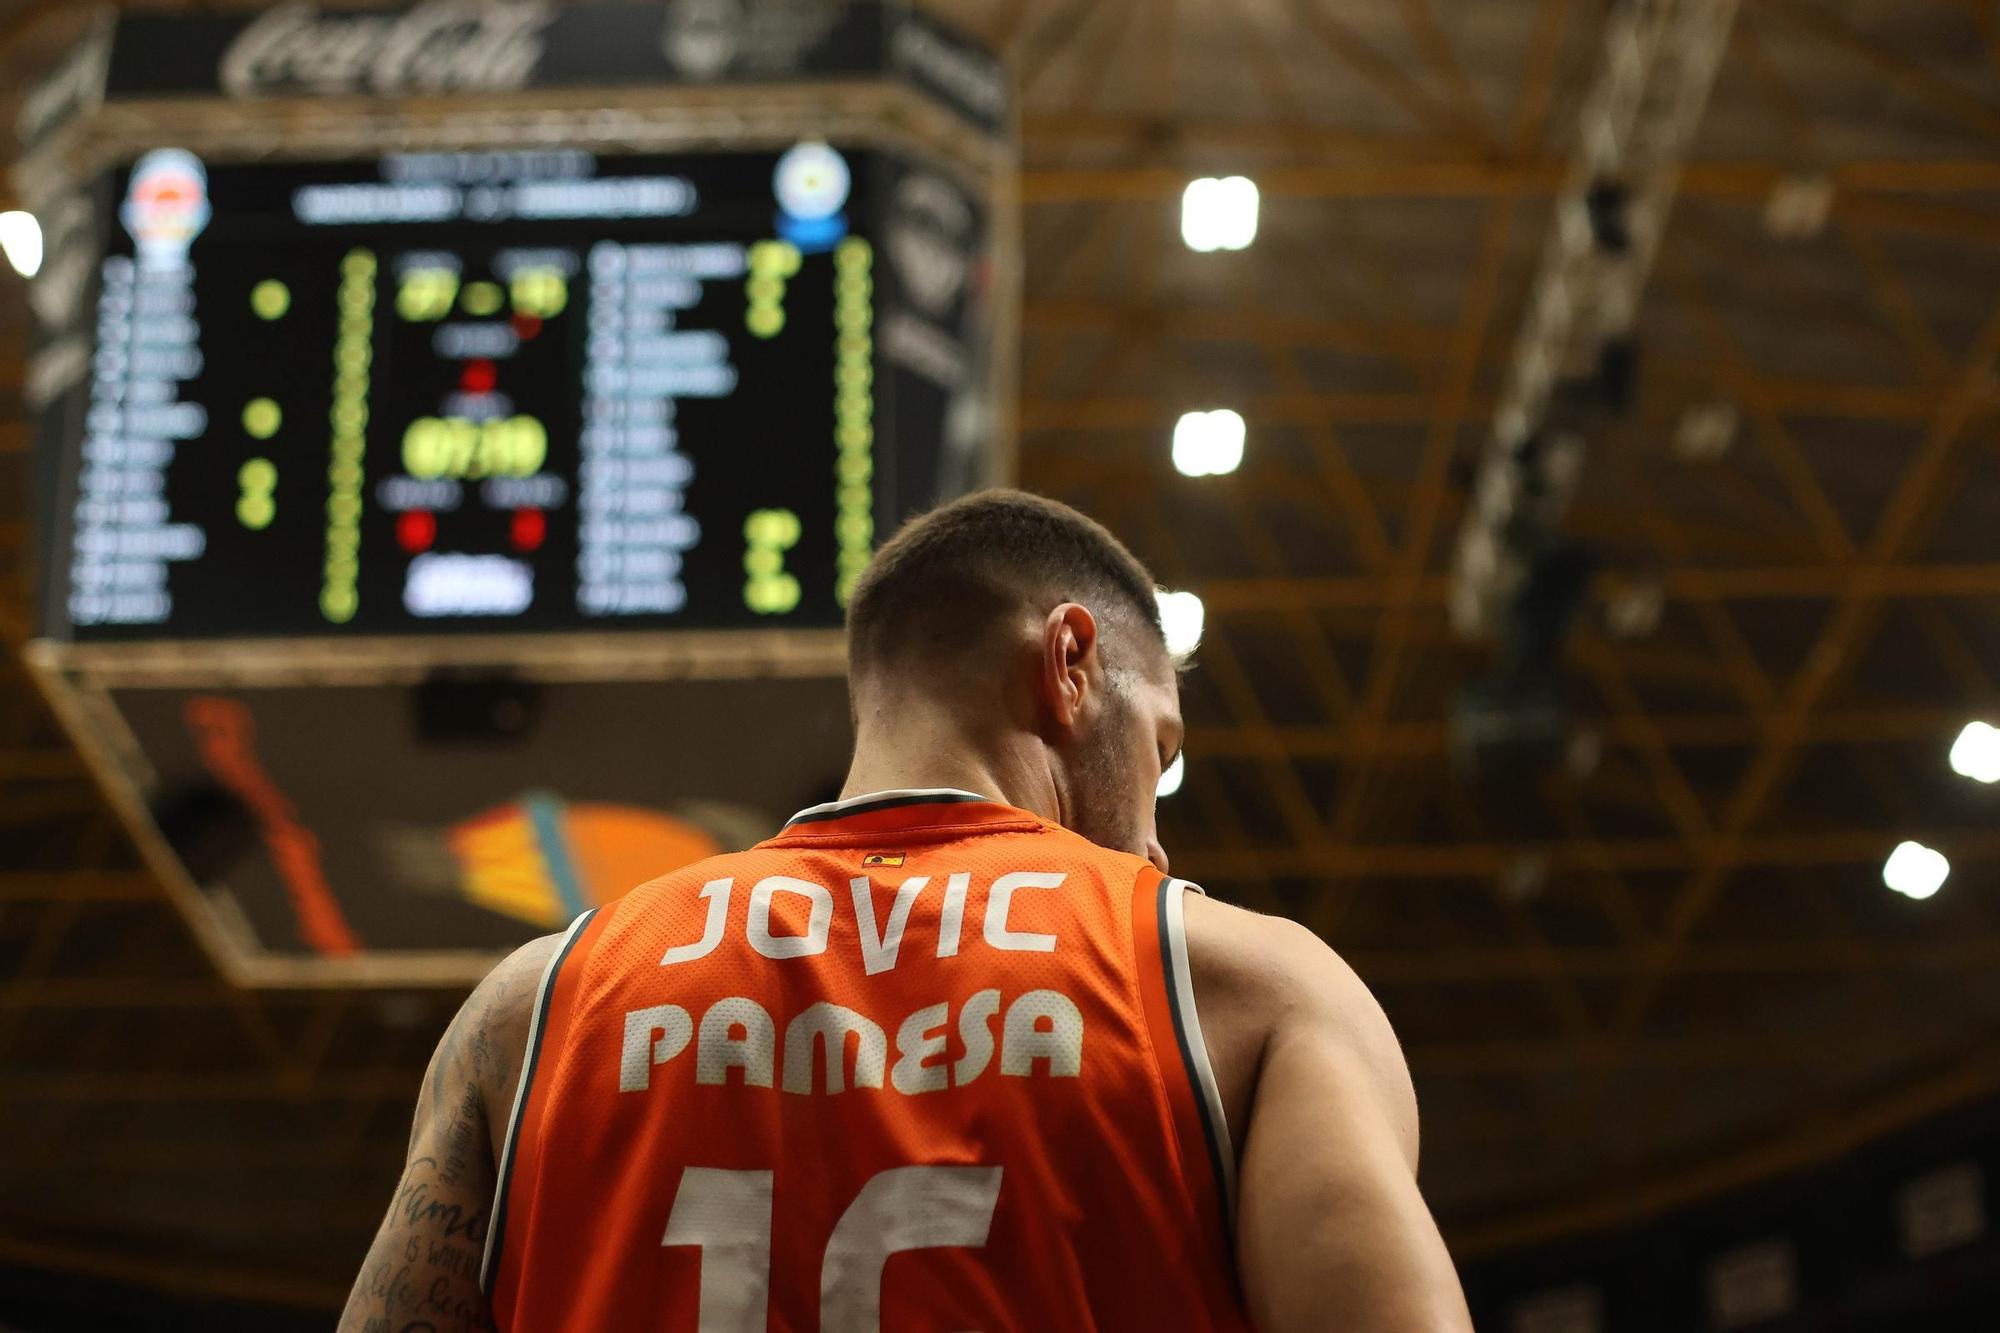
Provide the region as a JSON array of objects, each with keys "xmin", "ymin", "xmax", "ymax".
[{"xmin": 340, "ymin": 937, "xmax": 558, "ymax": 1333}]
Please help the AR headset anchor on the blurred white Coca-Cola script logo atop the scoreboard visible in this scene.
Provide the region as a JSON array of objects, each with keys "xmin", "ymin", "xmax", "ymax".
[{"xmin": 220, "ymin": 0, "xmax": 554, "ymax": 98}]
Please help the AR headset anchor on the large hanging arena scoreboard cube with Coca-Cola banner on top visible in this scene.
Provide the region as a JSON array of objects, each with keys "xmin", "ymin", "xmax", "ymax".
[{"xmin": 16, "ymin": 0, "xmax": 1018, "ymax": 985}]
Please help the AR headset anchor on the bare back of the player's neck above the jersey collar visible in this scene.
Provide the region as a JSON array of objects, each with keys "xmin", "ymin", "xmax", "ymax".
[{"xmin": 840, "ymin": 703, "xmax": 1060, "ymax": 819}]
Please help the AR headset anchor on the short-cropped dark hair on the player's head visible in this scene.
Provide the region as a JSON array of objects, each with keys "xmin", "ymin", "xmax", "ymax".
[{"xmin": 848, "ymin": 490, "xmax": 1166, "ymax": 681}]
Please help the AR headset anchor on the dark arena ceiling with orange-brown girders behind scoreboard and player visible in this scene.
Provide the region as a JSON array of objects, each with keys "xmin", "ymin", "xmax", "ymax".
[{"xmin": 0, "ymin": 0, "xmax": 2000, "ymax": 1301}]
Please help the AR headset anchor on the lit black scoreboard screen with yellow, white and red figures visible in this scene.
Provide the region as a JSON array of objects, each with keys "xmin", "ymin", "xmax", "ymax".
[{"xmin": 58, "ymin": 144, "xmax": 880, "ymax": 640}]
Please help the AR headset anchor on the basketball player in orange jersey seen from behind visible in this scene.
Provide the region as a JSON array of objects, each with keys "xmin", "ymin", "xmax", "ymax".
[{"xmin": 340, "ymin": 492, "xmax": 1470, "ymax": 1333}]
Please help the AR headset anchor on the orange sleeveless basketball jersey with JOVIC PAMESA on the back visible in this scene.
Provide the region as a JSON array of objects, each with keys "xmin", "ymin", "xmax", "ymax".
[{"xmin": 484, "ymin": 791, "xmax": 1248, "ymax": 1333}]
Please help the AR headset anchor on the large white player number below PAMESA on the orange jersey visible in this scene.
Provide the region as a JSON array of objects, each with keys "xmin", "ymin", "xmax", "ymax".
[{"xmin": 660, "ymin": 1167, "xmax": 1000, "ymax": 1333}]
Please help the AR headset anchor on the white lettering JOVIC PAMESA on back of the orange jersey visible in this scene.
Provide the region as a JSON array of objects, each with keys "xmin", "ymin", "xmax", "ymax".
[{"xmin": 618, "ymin": 871, "xmax": 1084, "ymax": 1095}]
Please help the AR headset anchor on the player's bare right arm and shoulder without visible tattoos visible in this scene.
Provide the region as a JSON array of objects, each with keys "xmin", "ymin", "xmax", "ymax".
[{"xmin": 1188, "ymin": 899, "xmax": 1472, "ymax": 1333}]
